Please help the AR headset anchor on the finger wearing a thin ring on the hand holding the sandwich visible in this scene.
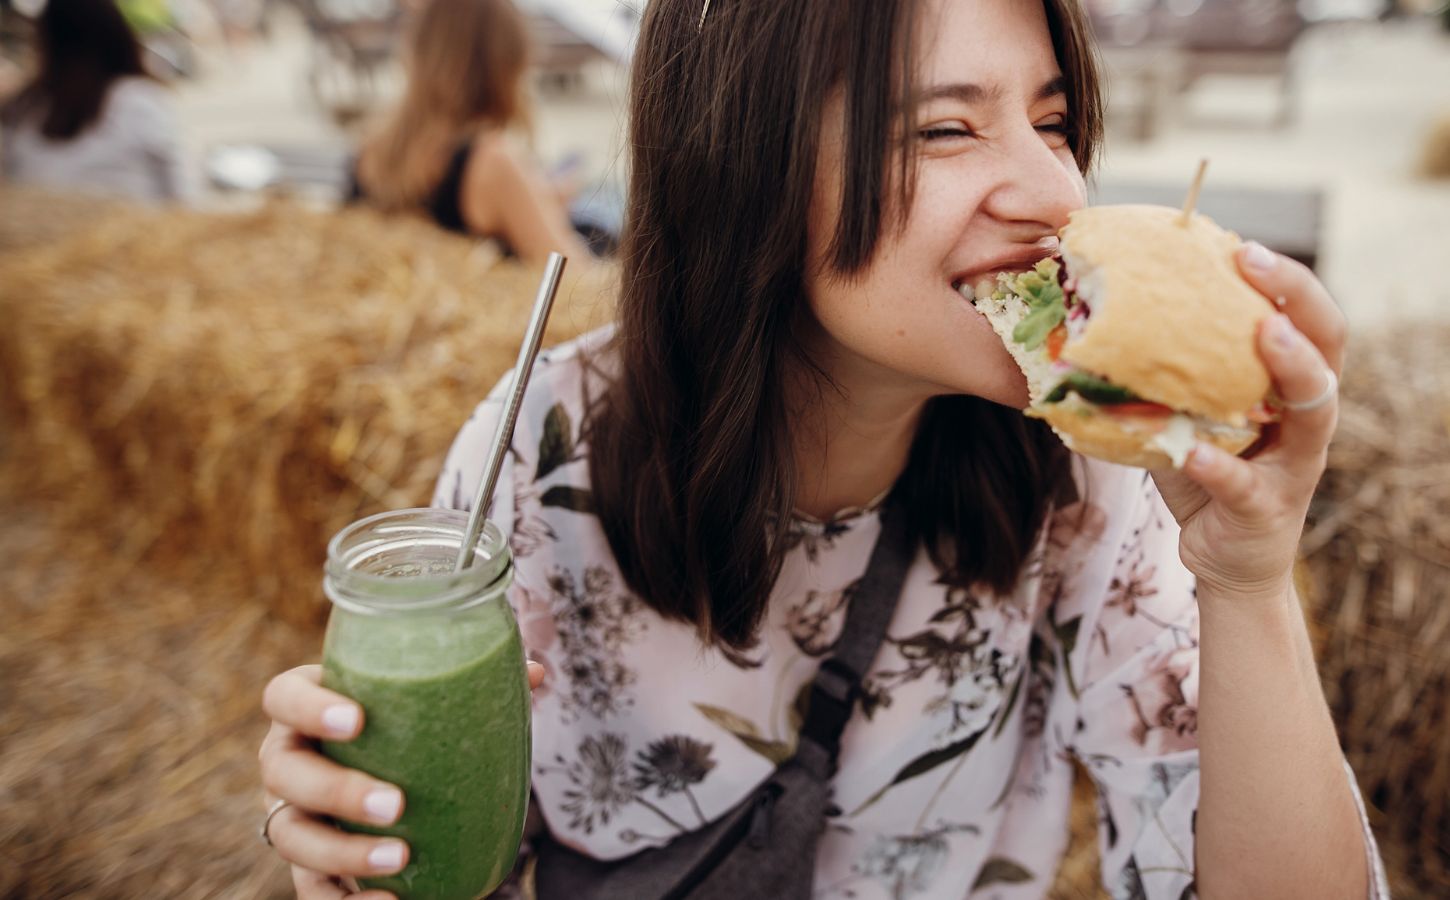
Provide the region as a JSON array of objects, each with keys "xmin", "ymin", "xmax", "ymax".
[{"xmin": 1259, "ymin": 316, "xmax": 1338, "ymax": 460}]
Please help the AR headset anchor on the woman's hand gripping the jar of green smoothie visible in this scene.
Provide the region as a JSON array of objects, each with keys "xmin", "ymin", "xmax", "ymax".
[{"xmin": 258, "ymin": 662, "xmax": 544, "ymax": 900}]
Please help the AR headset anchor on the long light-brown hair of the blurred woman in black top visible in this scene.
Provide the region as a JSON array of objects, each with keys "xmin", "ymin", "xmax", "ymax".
[{"xmin": 358, "ymin": 0, "xmax": 529, "ymax": 210}]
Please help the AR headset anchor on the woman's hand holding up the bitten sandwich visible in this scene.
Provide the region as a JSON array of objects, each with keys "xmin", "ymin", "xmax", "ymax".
[{"xmin": 1154, "ymin": 243, "xmax": 1347, "ymax": 597}]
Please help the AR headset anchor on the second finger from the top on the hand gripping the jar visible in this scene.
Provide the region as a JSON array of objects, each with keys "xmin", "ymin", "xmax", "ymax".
[{"xmin": 262, "ymin": 733, "xmax": 403, "ymax": 825}]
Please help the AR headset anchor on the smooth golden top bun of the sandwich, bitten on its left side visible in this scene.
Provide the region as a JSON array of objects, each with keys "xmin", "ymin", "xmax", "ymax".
[{"xmin": 1061, "ymin": 206, "xmax": 1273, "ymax": 428}]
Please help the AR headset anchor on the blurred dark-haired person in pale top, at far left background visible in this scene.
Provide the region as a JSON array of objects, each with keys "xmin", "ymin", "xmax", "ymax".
[{"xmin": 0, "ymin": 0, "xmax": 184, "ymax": 201}]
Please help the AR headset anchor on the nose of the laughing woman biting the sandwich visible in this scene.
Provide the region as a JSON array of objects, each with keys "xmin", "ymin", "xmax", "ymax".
[{"xmin": 985, "ymin": 126, "xmax": 1088, "ymax": 233}]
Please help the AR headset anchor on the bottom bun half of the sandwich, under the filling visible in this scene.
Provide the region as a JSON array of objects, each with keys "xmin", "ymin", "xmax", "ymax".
[{"xmin": 1028, "ymin": 396, "xmax": 1259, "ymax": 468}]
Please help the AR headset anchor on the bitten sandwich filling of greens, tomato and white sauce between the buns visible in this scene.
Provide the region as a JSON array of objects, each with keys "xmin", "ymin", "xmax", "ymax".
[{"xmin": 961, "ymin": 257, "xmax": 1275, "ymax": 467}]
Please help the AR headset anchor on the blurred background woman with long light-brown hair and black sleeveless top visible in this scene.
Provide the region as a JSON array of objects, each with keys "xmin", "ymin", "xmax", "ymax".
[{"xmin": 354, "ymin": 0, "xmax": 589, "ymax": 261}]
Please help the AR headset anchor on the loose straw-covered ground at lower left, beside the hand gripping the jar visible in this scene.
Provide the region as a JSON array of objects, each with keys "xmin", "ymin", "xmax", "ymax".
[{"xmin": 0, "ymin": 494, "xmax": 301, "ymax": 900}]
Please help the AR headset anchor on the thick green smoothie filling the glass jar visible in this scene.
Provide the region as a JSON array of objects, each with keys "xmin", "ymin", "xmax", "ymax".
[{"xmin": 322, "ymin": 576, "xmax": 531, "ymax": 900}]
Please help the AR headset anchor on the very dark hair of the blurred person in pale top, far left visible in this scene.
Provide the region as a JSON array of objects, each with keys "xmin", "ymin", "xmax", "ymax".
[{"xmin": 4, "ymin": 0, "xmax": 149, "ymax": 141}]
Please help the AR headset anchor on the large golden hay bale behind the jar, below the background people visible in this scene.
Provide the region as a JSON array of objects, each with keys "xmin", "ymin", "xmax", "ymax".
[{"xmin": 0, "ymin": 194, "xmax": 610, "ymax": 622}]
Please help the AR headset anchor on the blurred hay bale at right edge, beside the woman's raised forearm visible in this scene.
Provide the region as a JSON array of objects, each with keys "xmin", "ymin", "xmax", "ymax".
[{"xmin": 1301, "ymin": 323, "xmax": 1450, "ymax": 897}]
